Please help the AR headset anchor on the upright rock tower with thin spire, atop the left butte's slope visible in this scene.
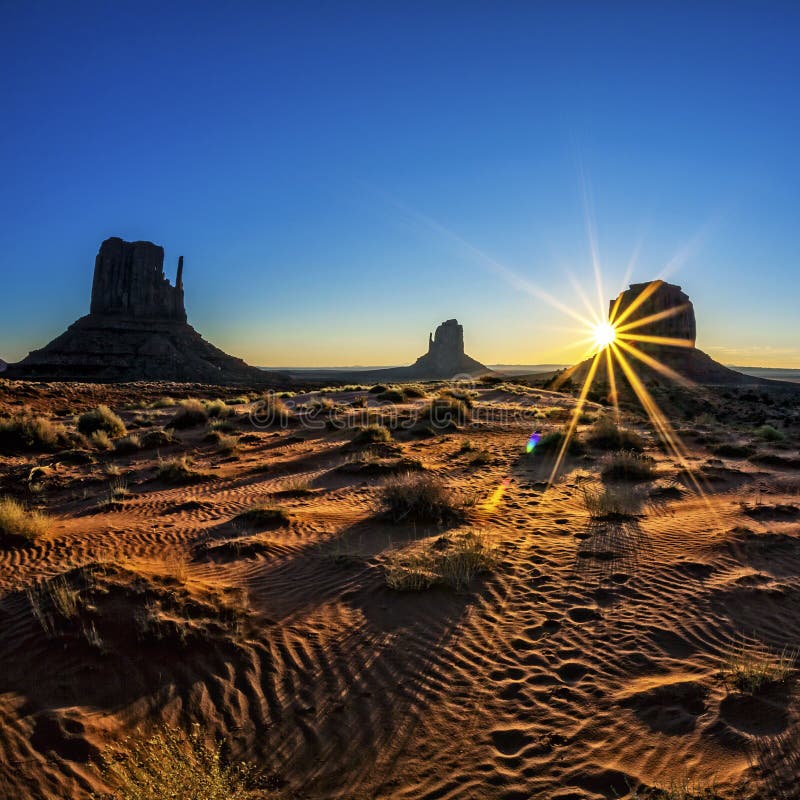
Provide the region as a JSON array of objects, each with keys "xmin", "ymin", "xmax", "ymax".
[{"xmin": 90, "ymin": 237, "xmax": 186, "ymax": 322}]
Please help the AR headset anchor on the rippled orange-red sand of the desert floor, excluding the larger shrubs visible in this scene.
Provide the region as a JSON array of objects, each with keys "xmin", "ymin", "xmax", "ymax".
[{"xmin": 0, "ymin": 382, "xmax": 800, "ymax": 800}]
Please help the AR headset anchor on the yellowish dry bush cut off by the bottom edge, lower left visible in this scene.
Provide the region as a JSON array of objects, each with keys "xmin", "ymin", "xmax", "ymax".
[{"xmin": 101, "ymin": 725, "xmax": 251, "ymax": 800}]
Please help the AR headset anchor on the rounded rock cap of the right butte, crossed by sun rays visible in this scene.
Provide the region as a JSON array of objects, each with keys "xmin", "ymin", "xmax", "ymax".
[{"xmin": 609, "ymin": 280, "xmax": 697, "ymax": 347}]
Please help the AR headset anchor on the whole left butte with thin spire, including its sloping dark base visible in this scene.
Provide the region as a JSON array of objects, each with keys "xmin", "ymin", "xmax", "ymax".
[{"xmin": 7, "ymin": 237, "xmax": 286, "ymax": 384}]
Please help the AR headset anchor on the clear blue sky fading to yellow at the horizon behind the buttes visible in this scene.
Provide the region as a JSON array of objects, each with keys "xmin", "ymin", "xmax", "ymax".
[{"xmin": 0, "ymin": 0, "xmax": 800, "ymax": 368}]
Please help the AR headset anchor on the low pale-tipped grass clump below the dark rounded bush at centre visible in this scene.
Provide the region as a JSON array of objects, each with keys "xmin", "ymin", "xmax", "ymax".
[{"xmin": 384, "ymin": 531, "xmax": 497, "ymax": 592}]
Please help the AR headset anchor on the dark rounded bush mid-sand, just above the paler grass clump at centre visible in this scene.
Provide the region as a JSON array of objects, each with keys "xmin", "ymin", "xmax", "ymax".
[{"xmin": 380, "ymin": 472, "xmax": 474, "ymax": 524}]
